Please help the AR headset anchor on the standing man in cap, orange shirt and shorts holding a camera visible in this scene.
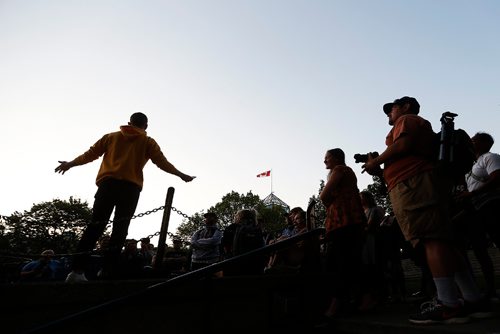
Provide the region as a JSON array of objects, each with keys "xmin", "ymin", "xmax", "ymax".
[{"xmin": 363, "ymin": 96, "xmax": 488, "ymax": 324}]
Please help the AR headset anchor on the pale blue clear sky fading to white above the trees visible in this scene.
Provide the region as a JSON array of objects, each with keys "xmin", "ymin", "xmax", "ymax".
[{"xmin": 0, "ymin": 0, "xmax": 500, "ymax": 244}]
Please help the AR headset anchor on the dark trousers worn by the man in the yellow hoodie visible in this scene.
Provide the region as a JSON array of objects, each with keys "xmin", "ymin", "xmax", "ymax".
[{"xmin": 73, "ymin": 178, "xmax": 141, "ymax": 269}]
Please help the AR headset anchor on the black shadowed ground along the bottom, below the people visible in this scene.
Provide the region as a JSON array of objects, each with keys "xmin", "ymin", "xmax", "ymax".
[{"xmin": 0, "ymin": 249, "xmax": 500, "ymax": 334}]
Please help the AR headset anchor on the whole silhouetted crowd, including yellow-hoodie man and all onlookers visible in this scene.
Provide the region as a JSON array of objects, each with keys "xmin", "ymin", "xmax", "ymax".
[{"xmin": 9, "ymin": 101, "xmax": 500, "ymax": 324}]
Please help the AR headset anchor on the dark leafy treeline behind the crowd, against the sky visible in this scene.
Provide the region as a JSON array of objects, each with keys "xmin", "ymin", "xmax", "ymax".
[{"xmin": 0, "ymin": 178, "xmax": 390, "ymax": 256}]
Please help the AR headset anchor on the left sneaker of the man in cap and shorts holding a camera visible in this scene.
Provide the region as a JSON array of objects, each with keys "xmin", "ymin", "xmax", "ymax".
[{"xmin": 408, "ymin": 300, "xmax": 470, "ymax": 325}]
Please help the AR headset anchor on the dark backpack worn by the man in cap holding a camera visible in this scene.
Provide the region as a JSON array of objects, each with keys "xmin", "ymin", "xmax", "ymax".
[{"xmin": 435, "ymin": 111, "xmax": 476, "ymax": 184}]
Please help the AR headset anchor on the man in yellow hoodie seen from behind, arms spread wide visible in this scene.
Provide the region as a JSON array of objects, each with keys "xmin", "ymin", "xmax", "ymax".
[{"xmin": 55, "ymin": 112, "xmax": 195, "ymax": 282}]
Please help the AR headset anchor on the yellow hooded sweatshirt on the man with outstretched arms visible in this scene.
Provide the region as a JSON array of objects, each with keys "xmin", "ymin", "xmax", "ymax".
[{"xmin": 73, "ymin": 125, "xmax": 178, "ymax": 189}]
